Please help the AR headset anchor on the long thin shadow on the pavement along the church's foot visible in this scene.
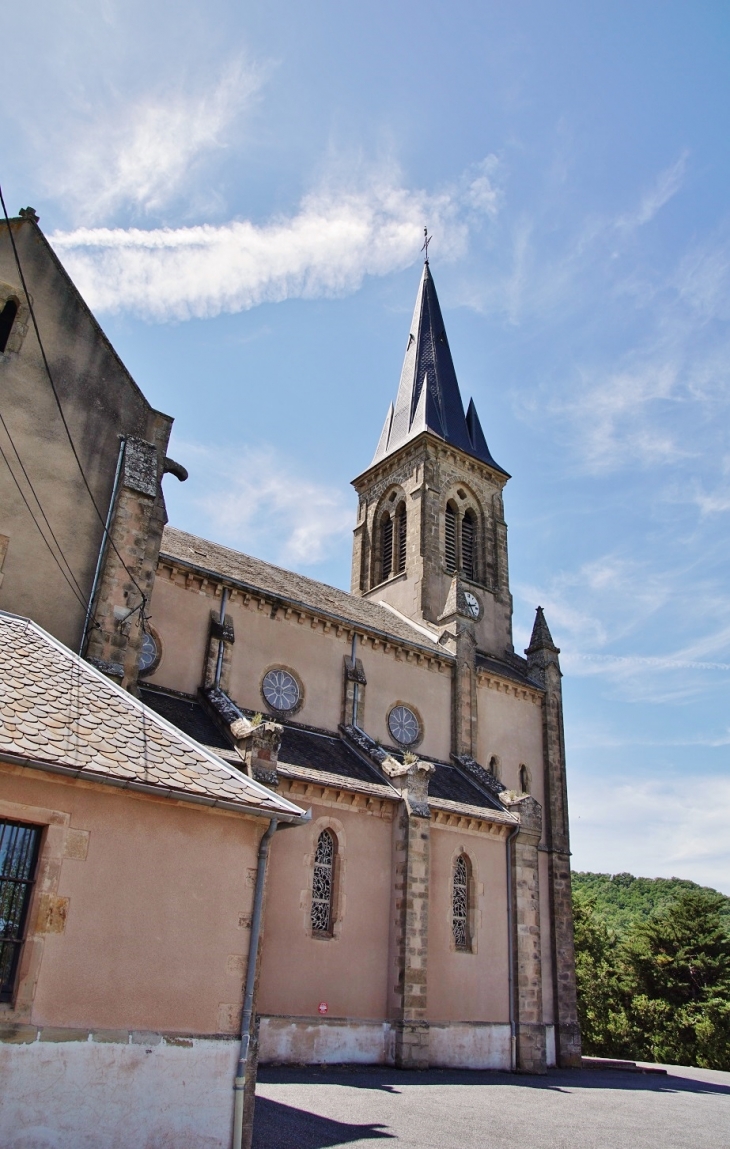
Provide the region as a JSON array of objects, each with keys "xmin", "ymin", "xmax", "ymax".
[{"xmin": 256, "ymin": 1065, "xmax": 730, "ymax": 1098}]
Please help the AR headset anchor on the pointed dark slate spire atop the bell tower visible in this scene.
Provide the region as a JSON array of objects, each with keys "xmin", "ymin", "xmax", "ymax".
[{"xmin": 372, "ymin": 260, "xmax": 507, "ymax": 475}]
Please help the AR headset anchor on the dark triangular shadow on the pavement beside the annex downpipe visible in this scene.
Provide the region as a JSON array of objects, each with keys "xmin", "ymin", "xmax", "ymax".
[{"xmin": 253, "ymin": 1093, "xmax": 394, "ymax": 1149}]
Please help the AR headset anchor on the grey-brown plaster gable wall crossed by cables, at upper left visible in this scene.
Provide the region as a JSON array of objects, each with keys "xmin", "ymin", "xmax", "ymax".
[{"xmin": 0, "ymin": 221, "xmax": 172, "ymax": 648}]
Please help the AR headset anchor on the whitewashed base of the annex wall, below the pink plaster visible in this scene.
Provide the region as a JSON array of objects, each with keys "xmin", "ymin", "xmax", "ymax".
[{"xmin": 0, "ymin": 1035, "xmax": 238, "ymax": 1149}]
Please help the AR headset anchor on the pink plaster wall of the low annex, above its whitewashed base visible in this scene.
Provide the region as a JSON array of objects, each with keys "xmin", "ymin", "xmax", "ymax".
[{"xmin": 0, "ymin": 764, "xmax": 263, "ymax": 1034}]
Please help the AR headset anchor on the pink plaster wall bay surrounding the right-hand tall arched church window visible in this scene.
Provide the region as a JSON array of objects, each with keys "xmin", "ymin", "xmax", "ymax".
[{"xmin": 428, "ymin": 825, "xmax": 509, "ymax": 1024}]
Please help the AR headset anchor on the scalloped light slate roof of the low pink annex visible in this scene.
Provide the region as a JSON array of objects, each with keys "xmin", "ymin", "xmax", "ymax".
[{"xmin": 0, "ymin": 611, "xmax": 305, "ymax": 822}]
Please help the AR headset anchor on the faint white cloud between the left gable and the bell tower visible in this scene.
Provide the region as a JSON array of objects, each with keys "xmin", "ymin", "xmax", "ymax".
[{"xmin": 175, "ymin": 442, "xmax": 354, "ymax": 568}]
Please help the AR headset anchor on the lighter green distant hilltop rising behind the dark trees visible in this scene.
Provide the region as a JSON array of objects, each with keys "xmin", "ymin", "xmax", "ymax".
[{"xmin": 573, "ymin": 871, "xmax": 730, "ymax": 934}]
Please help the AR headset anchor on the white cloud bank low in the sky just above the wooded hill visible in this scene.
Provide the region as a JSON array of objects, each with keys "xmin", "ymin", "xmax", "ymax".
[{"xmin": 570, "ymin": 772, "xmax": 730, "ymax": 893}]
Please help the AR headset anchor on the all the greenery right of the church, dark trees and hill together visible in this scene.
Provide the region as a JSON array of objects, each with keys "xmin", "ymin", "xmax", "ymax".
[{"xmin": 573, "ymin": 873, "xmax": 730, "ymax": 1070}]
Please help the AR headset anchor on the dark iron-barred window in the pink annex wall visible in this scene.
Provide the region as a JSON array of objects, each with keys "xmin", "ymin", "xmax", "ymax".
[{"xmin": 0, "ymin": 820, "xmax": 41, "ymax": 1002}]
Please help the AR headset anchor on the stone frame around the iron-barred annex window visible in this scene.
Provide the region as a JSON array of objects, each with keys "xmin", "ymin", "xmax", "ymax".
[{"xmin": 0, "ymin": 790, "xmax": 79, "ymax": 1025}]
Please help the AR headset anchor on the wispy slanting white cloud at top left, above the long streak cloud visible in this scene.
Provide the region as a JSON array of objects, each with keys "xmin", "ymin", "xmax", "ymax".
[{"xmin": 52, "ymin": 60, "xmax": 262, "ymax": 222}]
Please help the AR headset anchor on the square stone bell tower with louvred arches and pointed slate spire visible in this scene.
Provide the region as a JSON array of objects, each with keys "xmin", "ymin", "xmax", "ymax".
[{"xmin": 352, "ymin": 260, "xmax": 513, "ymax": 656}]
